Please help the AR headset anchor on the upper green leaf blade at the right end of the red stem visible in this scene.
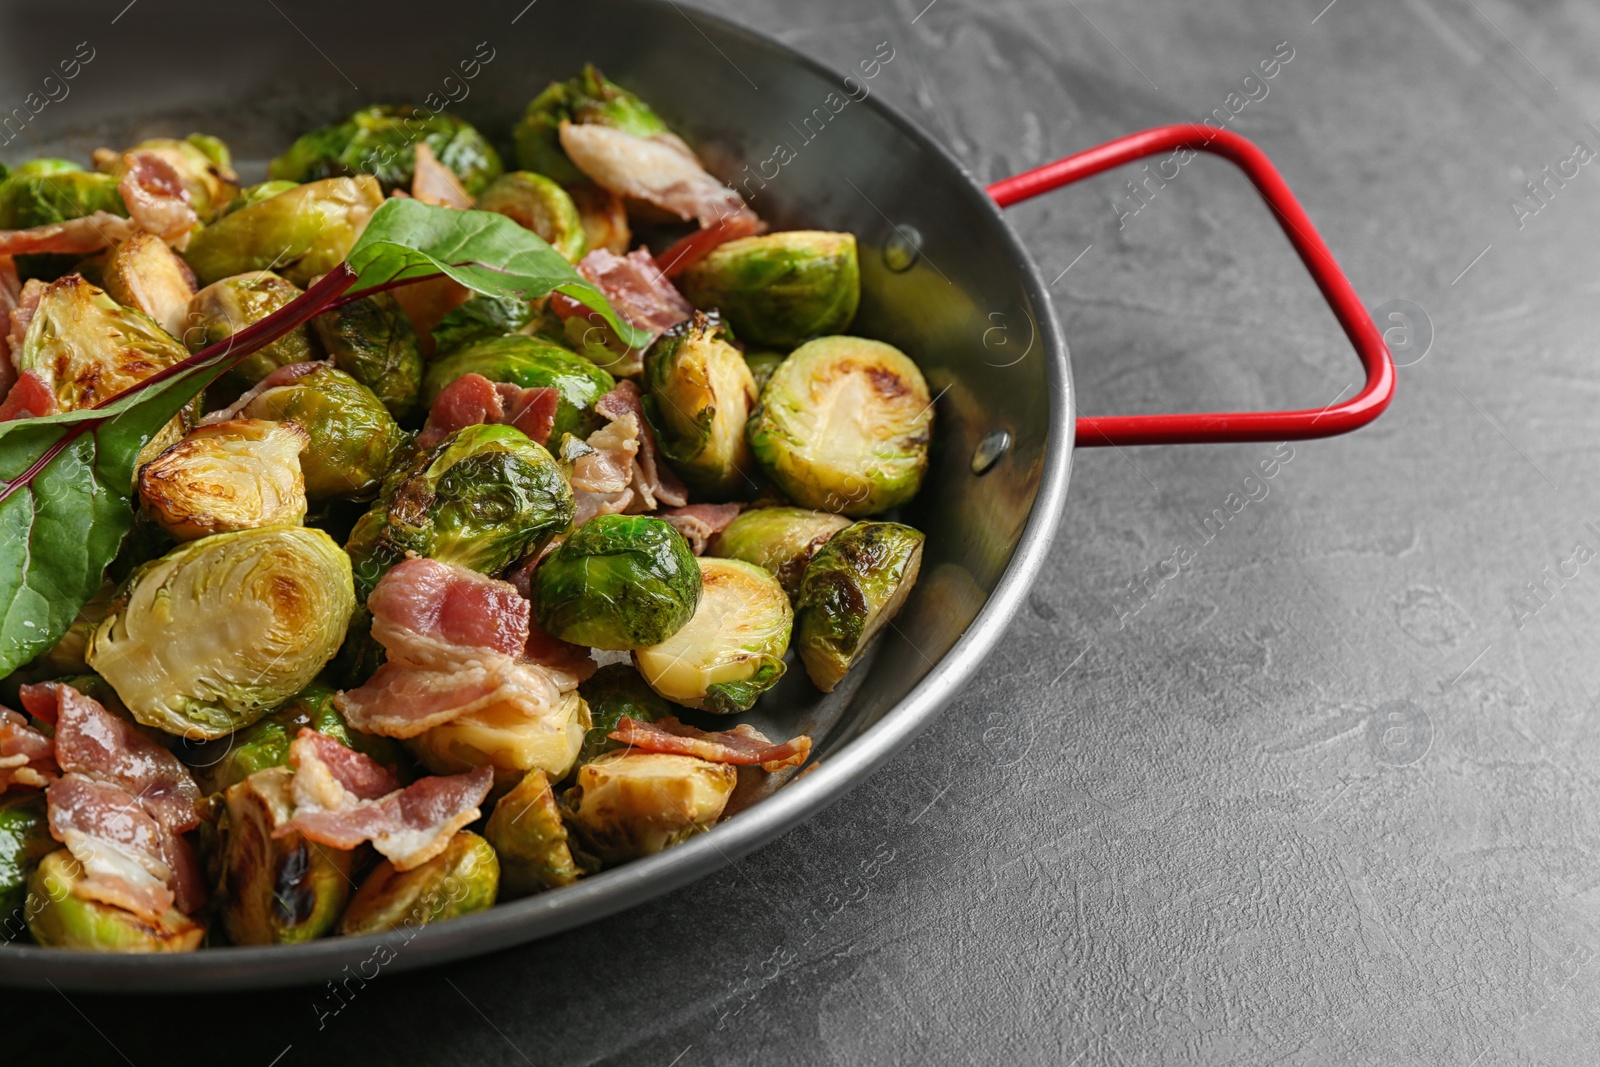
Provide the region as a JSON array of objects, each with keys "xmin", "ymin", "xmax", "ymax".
[{"xmin": 346, "ymin": 198, "xmax": 650, "ymax": 349}]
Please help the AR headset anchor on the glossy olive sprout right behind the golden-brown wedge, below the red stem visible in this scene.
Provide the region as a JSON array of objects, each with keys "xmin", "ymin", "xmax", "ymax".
[{"xmin": 240, "ymin": 366, "xmax": 406, "ymax": 501}]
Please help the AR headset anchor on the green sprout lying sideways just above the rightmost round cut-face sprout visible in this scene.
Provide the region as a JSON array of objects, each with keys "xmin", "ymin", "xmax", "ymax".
[{"xmin": 680, "ymin": 230, "xmax": 861, "ymax": 347}]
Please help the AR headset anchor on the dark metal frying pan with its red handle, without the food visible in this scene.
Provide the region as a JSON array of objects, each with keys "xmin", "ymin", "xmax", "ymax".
[{"xmin": 0, "ymin": 0, "xmax": 1394, "ymax": 992}]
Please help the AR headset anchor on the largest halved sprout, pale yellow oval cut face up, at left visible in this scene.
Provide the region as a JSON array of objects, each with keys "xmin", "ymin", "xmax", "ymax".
[{"xmin": 88, "ymin": 526, "xmax": 355, "ymax": 739}]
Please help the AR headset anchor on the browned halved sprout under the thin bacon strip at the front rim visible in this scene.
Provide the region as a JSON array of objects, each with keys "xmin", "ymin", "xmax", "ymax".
[{"xmin": 562, "ymin": 750, "xmax": 739, "ymax": 864}]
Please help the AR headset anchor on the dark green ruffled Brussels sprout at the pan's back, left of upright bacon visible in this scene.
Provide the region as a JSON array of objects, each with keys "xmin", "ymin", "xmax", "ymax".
[{"xmin": 267, "ymin": 104, "xmax": 502, "ymax": 197}]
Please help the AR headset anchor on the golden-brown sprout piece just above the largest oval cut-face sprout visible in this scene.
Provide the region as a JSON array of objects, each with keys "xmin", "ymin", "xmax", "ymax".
[{"xmin": 139, "ymin": 419, "xmax": 310, "ymax": 541}]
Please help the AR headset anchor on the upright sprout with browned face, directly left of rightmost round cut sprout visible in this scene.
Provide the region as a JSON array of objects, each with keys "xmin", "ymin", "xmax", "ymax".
[{"xmin": 643, "ymin": 312, "xmax": 757, "ymax": 499}]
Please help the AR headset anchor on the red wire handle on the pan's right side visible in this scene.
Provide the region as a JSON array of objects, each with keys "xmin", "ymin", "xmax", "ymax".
[{"xmin": 989, "ymin": 123, "xmax": 1395, "ymax": 446}]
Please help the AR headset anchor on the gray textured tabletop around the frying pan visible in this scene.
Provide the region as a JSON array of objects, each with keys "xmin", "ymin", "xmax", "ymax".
[{"xmin": 12, "ymin": 0, "xmax": 1600, "ymax": 1067}]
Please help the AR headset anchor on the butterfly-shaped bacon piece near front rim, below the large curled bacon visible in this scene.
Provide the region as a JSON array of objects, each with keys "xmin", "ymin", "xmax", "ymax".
[{"xmin": 284, "ymin": 728, "xmax": 494, "ymax": 870}]
